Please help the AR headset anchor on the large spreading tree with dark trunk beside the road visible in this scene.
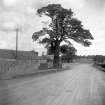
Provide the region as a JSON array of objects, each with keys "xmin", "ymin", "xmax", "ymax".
[{"xmin": 32, "ymin": 4, "xmax": 93, "ymax": 67}]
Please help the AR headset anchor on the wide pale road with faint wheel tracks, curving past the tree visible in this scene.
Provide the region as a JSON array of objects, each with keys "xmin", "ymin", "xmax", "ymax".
[{"xmin": 0, "ymin": 64, "xmax": 105, "ymax": 105}]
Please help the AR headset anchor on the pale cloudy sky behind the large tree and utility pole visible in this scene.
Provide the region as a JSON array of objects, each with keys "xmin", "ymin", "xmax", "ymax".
[{"xmin": 0, "ymin": 0, "xmax": 105, "ymax": 55}]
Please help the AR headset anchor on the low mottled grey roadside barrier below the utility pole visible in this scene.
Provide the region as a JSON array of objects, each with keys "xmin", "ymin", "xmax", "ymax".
[{"xmin": 0, "ymin": 60, "xmax": 40, "ymax": 79}]
